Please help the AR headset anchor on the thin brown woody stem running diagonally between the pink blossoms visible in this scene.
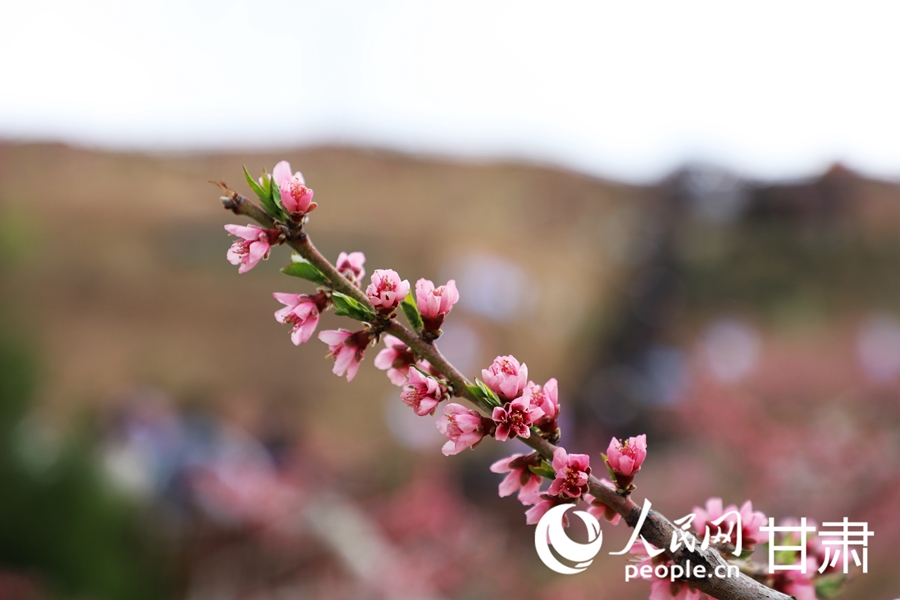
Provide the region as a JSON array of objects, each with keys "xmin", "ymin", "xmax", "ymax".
[{"xmin": 213, "ymin": 191, "xmax": 796, "ymax": 600}]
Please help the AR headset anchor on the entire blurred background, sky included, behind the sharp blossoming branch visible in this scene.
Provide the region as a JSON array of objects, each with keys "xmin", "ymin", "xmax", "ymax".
[{"xmin": 0, "ymin": 2, "xmax": 900, "ymax": 600}]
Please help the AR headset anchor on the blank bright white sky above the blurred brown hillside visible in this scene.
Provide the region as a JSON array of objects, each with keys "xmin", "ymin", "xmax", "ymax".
[{"xmin": 0, "ymin": 0, "xmax": 900, "ymax": 180}]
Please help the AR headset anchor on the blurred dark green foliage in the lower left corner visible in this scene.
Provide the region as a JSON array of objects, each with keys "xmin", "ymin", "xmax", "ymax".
[{"xmin": 0, "ymin": 338, "xmax": 171, "ymax": 600}]
